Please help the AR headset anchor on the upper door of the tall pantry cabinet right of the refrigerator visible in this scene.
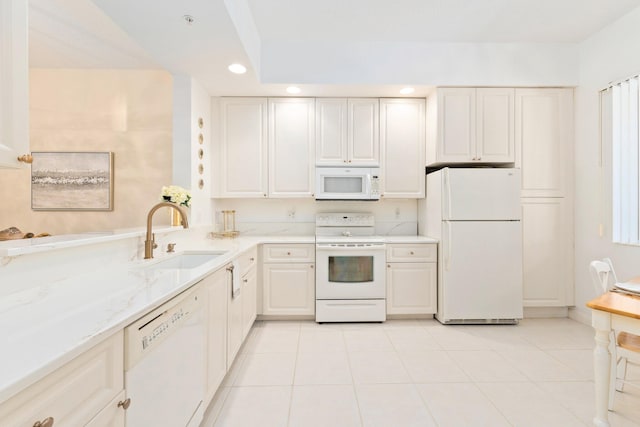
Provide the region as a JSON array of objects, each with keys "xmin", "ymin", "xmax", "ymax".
[{"xmin": 515, "ymin": 89, "xmax": 573, "ymax": 197}]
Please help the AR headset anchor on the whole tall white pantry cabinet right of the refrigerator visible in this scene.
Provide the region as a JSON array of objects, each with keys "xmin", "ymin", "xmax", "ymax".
[{"xmin": 515, "ymin": 88, "xmax": 574, "ymax": 307}]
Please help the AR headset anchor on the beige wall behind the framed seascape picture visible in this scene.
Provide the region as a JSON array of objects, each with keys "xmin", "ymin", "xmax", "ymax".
[{"xmin": 0, "ymin": 69, "xmax": 172, "ymax": 234}]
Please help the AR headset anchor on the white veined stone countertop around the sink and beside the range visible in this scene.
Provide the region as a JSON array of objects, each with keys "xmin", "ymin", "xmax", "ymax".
[{"xmin": 0, "ymin": 235, "xmax": 437, "ymax": 403}]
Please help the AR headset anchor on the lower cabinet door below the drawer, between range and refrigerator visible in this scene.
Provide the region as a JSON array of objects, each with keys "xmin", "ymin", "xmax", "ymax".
[{"xmin": 387, "ymin": 262, "xmax": 438, "ymax": 314}]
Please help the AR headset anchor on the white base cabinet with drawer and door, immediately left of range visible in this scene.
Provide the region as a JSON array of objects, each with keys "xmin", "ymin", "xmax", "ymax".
[{"xmin": 262, "ymin": 244, "xmax": 316, "ymax": 315}]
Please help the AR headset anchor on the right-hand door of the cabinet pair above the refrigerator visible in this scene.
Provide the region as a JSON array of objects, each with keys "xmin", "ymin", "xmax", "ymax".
[{"xmin": 475, "ymin": 88, "xmax": 516, "ymax": 163}]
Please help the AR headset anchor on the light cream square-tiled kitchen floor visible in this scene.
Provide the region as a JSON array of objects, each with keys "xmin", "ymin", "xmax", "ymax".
[{"xmin": 203, "ymin": 319, "xmax": 640, "ymax": 427}]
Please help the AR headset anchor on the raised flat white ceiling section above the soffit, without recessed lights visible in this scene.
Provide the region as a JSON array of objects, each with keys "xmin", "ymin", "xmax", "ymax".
[{"xmin": 248, "ymin": 0, "xmax": 640, "ymax": 43}]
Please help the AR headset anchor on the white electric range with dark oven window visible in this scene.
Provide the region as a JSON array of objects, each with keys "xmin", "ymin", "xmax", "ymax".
[{"xmin": 316, "ymin": 212, "xmax": 386, "ymax": 323}]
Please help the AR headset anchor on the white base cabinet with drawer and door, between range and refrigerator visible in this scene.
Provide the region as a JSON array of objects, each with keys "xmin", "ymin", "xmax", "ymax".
[{"xmin": 386, "ymin": 243, "xmax": 438, "ymax": 315}]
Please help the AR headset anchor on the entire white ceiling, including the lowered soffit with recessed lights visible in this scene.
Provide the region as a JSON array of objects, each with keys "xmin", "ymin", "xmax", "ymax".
[{"xmin": 29, "ymin": 0, "xmax": 640, "ymax": 96}]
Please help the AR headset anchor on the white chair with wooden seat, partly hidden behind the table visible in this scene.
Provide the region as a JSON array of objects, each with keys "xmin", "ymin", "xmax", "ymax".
[{"xmin": 589, "ymin": 258, "xmax": 640, "ymax": 411}]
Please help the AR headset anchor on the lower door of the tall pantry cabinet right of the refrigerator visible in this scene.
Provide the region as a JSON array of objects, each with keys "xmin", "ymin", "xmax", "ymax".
[{"xmin": 522, "ymin": 198, "xmax": 573, "ymax": 307}]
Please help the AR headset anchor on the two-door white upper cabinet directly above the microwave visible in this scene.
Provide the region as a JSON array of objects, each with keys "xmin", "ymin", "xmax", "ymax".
[{"xmin": 316, "ymin": 98, "xmax": 380, "ymax": 166}]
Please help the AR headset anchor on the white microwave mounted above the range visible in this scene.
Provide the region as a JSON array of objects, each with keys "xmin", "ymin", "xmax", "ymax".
[{"xmin": 316, "ymin": 166, "xmax": 380, "ymax": 200}]
